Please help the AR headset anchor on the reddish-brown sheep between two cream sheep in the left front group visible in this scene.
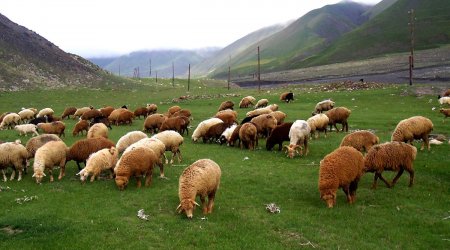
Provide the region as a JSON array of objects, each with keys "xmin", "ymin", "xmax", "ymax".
[{"xmin": 66, "ymin": 137, "xmax": 116, "ymax": 170}]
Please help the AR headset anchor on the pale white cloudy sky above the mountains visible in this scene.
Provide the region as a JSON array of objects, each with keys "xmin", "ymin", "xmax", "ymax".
[{"xmin": 0, "ymin": 0, "xmax": 381, "ymax": 57}]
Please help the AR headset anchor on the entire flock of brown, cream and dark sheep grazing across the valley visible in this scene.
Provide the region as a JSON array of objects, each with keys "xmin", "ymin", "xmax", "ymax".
[{"xmin": 0, "ymin": 88, "xmax": 450, "ymax": 218}]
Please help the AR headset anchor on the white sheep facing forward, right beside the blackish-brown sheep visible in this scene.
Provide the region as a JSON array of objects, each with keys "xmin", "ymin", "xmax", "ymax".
[{"xmin": 284, "ymin": 120, "xmax": 311, "ymax": 159}]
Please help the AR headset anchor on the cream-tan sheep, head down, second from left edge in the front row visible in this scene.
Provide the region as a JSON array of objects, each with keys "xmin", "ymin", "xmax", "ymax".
[{"xmin": 32, "ymin": 141, "xmax": 68, "ymax": 184}]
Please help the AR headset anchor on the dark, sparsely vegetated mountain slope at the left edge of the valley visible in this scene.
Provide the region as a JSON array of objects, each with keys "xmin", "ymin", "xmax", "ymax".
[{"xmin": 0, "ymin": 14, "xmax": 123, "ymax": 91}]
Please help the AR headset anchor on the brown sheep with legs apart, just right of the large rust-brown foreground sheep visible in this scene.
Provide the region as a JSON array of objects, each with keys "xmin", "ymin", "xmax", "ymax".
[{"xmin": 364, "ymin": 141, "xmax": 417, "ymax": 189}]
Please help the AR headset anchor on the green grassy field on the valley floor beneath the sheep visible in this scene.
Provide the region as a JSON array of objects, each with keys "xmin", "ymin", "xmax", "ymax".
[{"xmin": 0, "ymin": 80, "xmax": 450, "ymax": 249}]
